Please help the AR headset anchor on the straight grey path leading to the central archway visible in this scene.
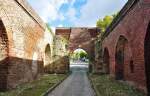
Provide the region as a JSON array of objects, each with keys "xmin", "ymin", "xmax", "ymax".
[{"xmin": 48, "ymin": 63, "xmax": 95, "ymax": 96}]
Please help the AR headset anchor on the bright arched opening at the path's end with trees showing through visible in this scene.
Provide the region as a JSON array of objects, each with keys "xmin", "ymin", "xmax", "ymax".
[{"xmin": 70, "ymin": 48, "xmax": 89, "ymax": 70}]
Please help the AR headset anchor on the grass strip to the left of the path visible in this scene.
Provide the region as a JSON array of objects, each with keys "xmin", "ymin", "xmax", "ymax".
[{"xmin": 0, "ymin": 74, "xmax": 67, "ymax": 96}]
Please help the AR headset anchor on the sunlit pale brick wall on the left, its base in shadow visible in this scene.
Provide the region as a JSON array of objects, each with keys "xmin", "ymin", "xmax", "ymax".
[{"xmin": 0, "ymin": 0, "xmax": 51, "ymax": 90}]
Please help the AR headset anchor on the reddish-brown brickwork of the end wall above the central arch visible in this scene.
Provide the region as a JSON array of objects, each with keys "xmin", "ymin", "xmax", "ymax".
[{"xmin": 56, "ymin": 27, "xmax": 98, "ymax": 59}]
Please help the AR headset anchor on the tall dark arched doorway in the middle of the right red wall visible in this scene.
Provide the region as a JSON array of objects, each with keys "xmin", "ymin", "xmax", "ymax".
[{"xmin": 115, "ymin": 36, "xmax": 127, "ymax": 80}]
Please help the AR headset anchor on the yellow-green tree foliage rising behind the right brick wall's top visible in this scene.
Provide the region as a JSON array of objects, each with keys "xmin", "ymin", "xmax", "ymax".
[{"xmin": 96, "ymin": 14, "xmax": 117, "ymax": 32}]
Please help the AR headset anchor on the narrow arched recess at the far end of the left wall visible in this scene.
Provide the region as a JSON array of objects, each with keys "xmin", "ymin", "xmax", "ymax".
[{"xmin": 44, "ymin": 44, "xmax": 52, "ymax": 72}]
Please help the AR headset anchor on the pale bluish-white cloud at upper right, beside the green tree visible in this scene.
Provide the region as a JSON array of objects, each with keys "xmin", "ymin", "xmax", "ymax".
[{"xmin": 74, "ymin": 0, "xmax": 127, "ymax": 26}]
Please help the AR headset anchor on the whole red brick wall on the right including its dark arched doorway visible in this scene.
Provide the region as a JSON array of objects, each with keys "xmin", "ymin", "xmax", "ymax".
[{"xmin": 102, "ymin": 0, "xmax": 150, "ymax": 91}]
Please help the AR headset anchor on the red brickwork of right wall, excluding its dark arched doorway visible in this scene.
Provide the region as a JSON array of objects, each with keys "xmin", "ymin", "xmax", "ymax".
[{"xmin": 102, "ymin": 0, "xmax": 150, "ymax": 90}]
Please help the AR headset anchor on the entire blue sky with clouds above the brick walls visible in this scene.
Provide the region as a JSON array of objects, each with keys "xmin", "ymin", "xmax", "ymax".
[{"xmin": 27, "ymin": 0, "xmax": 127, "ymax": 28}]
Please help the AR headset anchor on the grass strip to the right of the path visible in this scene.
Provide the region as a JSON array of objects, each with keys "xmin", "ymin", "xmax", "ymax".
[{"xmin": 89, "ymin": 75, "xmax": 146, "ymax": 96}]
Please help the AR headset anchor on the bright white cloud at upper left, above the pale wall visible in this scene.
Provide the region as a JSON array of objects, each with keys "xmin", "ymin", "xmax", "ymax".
[{"xmin": 28, "ymin": 0, "xmax": 68, "ymax": 22}]
